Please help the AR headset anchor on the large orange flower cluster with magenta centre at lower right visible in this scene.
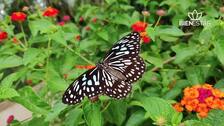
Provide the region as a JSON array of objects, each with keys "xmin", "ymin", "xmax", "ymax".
[{"xmin": 174, "ymin": 84, "xmax": 224, "ymax": 117}]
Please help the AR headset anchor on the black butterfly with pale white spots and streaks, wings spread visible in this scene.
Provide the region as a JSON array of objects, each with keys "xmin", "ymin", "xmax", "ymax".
[{"xmin": 62, "ymin": 32, "xmax": 145, "ymax": 104}]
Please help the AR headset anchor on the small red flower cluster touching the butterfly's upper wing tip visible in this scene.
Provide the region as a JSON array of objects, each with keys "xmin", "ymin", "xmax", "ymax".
[{"xmin": 131, "ymin": 21, "xmax": 151, "ymax": 43}]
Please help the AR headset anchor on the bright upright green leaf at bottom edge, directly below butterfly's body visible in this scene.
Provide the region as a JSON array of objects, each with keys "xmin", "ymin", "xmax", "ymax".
[{"xmin": 83, "ymin": 103, "xmax": 103, "ymax": 126}]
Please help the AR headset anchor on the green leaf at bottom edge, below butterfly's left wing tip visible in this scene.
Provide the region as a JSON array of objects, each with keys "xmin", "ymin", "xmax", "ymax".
[{"xmin": 65, "ymin": 108, "xmax": 83, "ymax": 126}]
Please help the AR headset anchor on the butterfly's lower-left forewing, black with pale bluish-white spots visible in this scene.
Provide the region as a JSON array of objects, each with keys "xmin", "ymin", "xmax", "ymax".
[{"xmin": 62, "ymin": 67, "xmax": 103, "ymax": 104}]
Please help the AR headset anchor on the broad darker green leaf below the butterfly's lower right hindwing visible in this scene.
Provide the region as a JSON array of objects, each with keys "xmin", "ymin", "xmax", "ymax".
[{"xmin": 104, "ymin": 101, "xmax": 127, "ymax": 126}]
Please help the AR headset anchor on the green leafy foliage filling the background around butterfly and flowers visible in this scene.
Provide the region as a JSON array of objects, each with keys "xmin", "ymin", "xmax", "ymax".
[{"xmin": 0, "ymin": 0, "xmax": 224, "ymax": 126}]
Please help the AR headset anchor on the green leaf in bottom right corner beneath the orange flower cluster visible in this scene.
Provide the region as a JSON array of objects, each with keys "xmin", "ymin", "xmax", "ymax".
[{"xmin": 202, "ymin": 109, "xmax": 224, "ymax": 126}]
